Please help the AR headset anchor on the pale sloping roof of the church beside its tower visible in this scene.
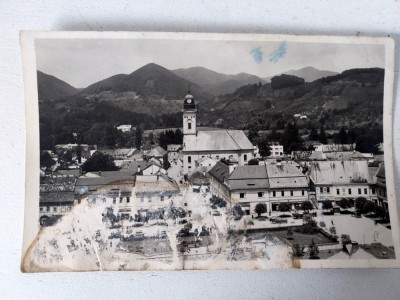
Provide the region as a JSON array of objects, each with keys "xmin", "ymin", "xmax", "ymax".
[{"xmin": 183, "ymin": 130, "xmax": 254, "ymax": 151}]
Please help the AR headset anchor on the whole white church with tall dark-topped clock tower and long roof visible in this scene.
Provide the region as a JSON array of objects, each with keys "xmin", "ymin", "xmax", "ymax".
[{"xmin": 182, "ymin": 92, "xmax": 254, "ymax": 174}]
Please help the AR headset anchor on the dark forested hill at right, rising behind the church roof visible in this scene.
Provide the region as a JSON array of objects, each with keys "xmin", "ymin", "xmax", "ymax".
[{"xmin": 205, "ymin": 68, "xmax": 384, "ymax": 129}]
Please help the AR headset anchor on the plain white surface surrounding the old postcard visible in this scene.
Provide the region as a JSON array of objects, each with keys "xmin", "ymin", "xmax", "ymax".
[{"xmin": 0, "ymin": 0, "xmax": 400, "ymax": 299}]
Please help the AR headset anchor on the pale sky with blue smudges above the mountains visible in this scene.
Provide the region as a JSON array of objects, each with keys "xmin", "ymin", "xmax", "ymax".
[{"xmin": 35, "ymin": 39, "xmax": 384, "ymax": 88}]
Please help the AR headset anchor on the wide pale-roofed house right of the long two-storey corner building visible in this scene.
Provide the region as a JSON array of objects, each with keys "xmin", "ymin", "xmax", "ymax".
[{"xmin": 308, "ymin": 160, "xmax": 371, "ymax": 205}]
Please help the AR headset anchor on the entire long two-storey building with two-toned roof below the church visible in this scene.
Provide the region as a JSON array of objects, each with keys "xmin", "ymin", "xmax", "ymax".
[{"xmin": 209, "ymin": 162, "xmax": 309, "ymax": 214}]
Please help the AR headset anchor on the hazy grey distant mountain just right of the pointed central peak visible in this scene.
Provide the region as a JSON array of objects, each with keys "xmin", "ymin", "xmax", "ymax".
[{"xmin": 172, "ymin": 67, "xmax": 265, "ymax": 95}]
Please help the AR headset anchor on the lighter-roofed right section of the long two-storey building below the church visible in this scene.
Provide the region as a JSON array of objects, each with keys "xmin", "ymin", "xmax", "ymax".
[{"xmin": 266, "ymin": 164, "xmax": 309, "ymax": 211}]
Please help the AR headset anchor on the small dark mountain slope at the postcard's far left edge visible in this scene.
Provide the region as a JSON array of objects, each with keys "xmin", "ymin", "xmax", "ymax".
[{"xmin": 37, "ymin": 71, "xmax": 79, "ymax": 100}]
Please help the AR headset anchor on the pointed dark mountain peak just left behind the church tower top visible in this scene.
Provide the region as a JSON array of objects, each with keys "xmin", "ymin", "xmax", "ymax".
[{"xmin": 80, "ymin": 63, "xmax": 208, "ymax": 100}]
